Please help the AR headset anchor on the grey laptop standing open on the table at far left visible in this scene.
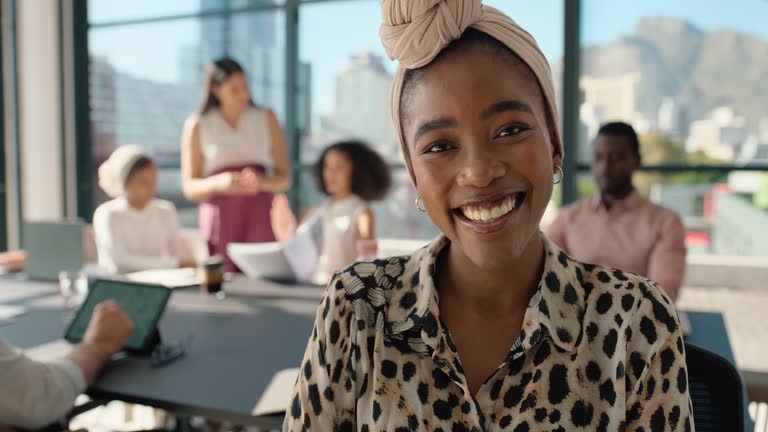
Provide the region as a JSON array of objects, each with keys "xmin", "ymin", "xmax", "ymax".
[{"xmin": 22, "ymin": 221, "xmax": 85, "ymax": 281}]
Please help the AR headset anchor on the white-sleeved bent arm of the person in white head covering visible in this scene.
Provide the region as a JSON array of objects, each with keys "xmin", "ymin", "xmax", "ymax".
[{"xmin": 93, "ymin": 210, "xmax": 179, "ymax": 273}]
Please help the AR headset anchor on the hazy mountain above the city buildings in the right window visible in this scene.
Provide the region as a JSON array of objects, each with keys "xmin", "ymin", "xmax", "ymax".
[{"xmin": 553, "ymin": 17, "xmax": 768, "ymax": 127}]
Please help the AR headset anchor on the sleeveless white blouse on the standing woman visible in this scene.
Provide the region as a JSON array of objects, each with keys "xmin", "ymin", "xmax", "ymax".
[{"xmin": 200, "ymin": 107, "xmax": 274, "ymax": 175}]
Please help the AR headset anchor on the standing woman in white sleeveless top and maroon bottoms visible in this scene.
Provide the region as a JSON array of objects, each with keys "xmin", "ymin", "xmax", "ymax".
[{"xmin": 181, "ymin": 58, "xmax": 291, "ymax": 271}]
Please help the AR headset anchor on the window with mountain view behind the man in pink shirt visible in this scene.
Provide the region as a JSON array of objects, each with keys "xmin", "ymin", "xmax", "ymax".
[{"xmin": 579, "ymin": 0, "xmax": 768, "ymax": 255}]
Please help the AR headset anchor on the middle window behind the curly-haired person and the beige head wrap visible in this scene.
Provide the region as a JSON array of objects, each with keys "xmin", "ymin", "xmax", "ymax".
[{"xmin": 299, "ymin": 0, "xmax": 563, "ymax": 239}]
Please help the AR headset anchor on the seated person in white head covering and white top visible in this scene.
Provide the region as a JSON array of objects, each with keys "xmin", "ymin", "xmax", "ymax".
[{"xmin": 93, "ymin": 145, "xmax": 195, "ymax": 273}]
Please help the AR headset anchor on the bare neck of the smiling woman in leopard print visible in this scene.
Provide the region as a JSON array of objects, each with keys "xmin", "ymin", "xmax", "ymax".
[{"xmin": 439, "ymin": 233, "xmax": 544, "ymax": 314}]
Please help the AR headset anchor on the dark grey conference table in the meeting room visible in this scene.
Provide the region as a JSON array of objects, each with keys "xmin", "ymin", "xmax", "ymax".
[{"xmin": 0, "ymin": 275, "xmax": 752, "ymax": 429}]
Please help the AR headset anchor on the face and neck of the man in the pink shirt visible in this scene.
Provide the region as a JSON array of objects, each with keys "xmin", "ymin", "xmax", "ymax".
[{"xmin": 592, "ymin": 134, "xmax": 641, "ymax": 209}]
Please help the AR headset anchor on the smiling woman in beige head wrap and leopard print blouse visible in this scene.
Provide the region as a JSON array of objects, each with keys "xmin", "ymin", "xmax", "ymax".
[{"xmin": 284, "ymin": 0, "xmax": 692, "ymax": 431}]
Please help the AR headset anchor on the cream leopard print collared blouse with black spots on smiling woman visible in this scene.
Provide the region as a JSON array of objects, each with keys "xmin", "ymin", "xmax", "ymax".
[{"xmin": 283, "ymin": 236, "xmax": 693, "ymax": 432}]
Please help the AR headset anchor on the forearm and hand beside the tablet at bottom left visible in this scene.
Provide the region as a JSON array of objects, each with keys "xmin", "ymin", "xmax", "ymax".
[{"xmin": 0, "ymin": 302, "xmax": 133, "ymax": 429}]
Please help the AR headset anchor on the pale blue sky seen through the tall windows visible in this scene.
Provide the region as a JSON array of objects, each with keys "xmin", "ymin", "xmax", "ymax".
[{"xmin": 89, "ymin": 0, "xmax": 768, "ymax": 116}]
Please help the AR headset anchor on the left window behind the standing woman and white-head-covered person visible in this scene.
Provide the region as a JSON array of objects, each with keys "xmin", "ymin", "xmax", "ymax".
[{"xmin": 89, "ymin": 6, "xmax": 286, "ymax": 226}]
